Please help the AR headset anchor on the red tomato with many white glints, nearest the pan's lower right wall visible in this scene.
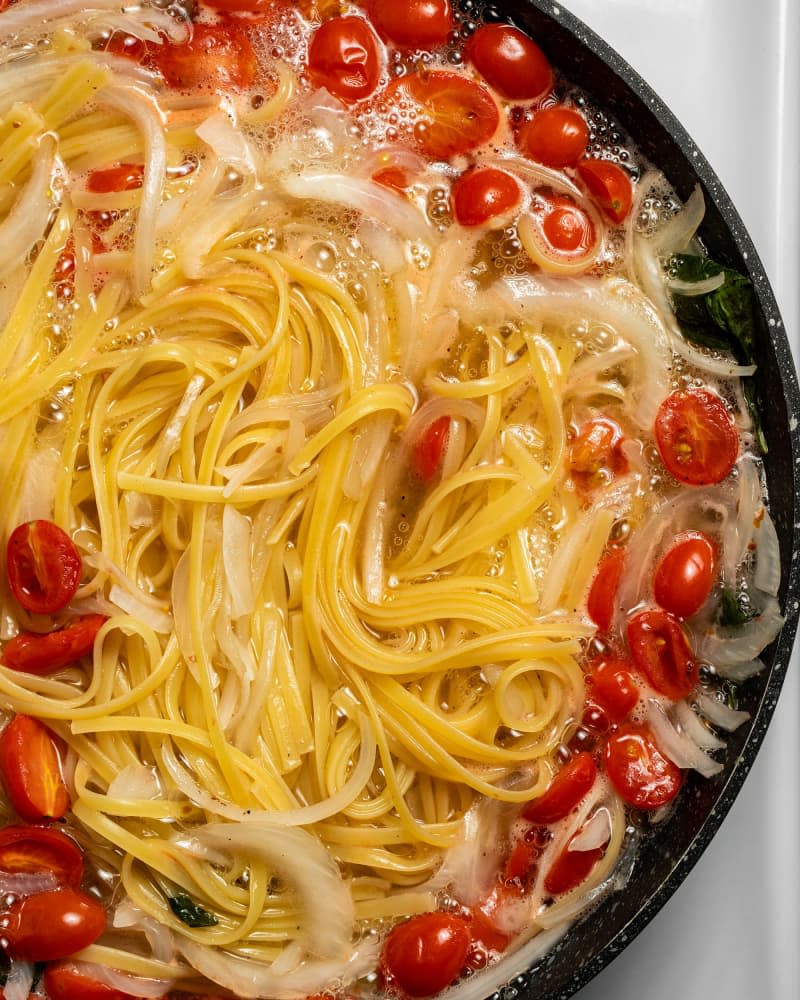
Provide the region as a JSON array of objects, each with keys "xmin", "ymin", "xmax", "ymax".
[{"xmin": 605, "ymin": 722, "xmax": 683, "ymax": 809}]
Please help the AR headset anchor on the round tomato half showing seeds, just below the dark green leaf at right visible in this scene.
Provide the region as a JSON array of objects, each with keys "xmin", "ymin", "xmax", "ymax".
[{"xmin": 655, "ymin": 389, "xmax": 739, "ymax": 486}]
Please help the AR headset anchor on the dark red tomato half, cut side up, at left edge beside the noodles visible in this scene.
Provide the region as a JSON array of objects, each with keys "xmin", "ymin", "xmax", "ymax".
[{"xmin": 6, "ymin": 521, "xmax": 83, "ymax": 615}]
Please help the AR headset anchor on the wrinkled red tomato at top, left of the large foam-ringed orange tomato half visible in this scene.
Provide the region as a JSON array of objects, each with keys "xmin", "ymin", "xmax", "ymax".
[{"xmin": 308, "ymin": 16, "xmax": 382, "ymax": 103}]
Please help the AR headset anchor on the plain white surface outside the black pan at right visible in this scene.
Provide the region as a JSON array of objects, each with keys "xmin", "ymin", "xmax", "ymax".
[{"xmin": 562, "ymin": 0, "xmax": 800, "ymax": 1000}]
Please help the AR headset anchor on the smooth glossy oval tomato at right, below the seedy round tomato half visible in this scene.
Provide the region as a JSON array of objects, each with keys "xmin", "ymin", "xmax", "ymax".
[{"xmin": 653, "ymin": 531, "xmax": 717, "ymax": 618}]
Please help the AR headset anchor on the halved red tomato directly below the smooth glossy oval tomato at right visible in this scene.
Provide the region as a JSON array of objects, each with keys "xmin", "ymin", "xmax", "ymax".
[{"xmin": 627, "ymin": 611, "xmax": 698, "ymax": 701}]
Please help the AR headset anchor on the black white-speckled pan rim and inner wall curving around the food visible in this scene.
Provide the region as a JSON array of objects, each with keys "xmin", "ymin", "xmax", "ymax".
[{"xmin": 462, "ymin": 0, "xmax": 800, "ymax": 1000}]
